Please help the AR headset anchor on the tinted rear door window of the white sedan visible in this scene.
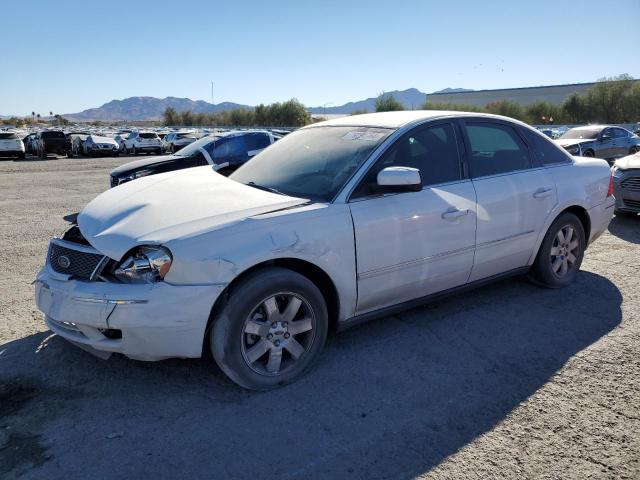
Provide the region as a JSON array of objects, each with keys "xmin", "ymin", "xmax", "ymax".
[{"xmin": 465, "ymin": 122, "xmax": 531, "ymax": 178}]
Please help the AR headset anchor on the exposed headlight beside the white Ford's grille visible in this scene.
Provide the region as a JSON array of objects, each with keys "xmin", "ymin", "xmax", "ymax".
[{"xmin": 113, "ymin": 246, "xmax": 172, "ymax": 283}]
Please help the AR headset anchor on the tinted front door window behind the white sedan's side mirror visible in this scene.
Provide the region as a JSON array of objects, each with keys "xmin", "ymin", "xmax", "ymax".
[{"xmin": 352, "ymin": 123, "xmax": 462, "ymax": 198}]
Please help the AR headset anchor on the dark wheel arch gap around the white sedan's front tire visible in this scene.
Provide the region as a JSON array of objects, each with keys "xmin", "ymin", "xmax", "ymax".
[{"xmin": 203, "ymin": 257, "xmax": 340, "ymax": 349}]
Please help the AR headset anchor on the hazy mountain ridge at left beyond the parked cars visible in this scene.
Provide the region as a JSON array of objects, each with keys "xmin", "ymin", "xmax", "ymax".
[{"xmin": 63, "ymin": 97, "xmax": 253, "ymax": 122}]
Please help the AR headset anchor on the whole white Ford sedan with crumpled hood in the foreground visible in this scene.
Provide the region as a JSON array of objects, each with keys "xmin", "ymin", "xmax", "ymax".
[{"xmin": 35, "ymin": 111, "xmax": 615, "ymax": 390}]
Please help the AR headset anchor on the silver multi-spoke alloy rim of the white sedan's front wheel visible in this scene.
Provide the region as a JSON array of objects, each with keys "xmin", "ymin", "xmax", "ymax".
[{"xmin": 241, "ymin": 292, "xmax": 316, "ymax": 376}]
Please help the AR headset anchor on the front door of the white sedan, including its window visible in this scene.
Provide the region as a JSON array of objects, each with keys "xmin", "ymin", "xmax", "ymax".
[{"xmin": 350, "ymin": 122, "xmax": 476, "ymax": 314}]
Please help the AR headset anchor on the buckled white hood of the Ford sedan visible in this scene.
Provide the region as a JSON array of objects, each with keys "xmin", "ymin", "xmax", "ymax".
[{"xmin": 78, "ymin": 166, "xmax": 308, "ymax": 260}]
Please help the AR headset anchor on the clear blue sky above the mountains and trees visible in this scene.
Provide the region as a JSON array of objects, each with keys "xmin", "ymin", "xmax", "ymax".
[{"xmin": 0, "ymin": 0, "xmax": 640, "ymax": 115}]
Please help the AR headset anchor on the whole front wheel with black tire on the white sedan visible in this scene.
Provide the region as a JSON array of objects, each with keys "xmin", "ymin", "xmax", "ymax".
[{"xmin": 209, "ymin": 268, "xmax": 328, "ymax": 390}]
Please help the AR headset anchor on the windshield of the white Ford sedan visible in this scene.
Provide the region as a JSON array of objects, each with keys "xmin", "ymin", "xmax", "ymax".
[{"xmin": 229, "ymin": 126, "xmax": 393, "ymax": 202}]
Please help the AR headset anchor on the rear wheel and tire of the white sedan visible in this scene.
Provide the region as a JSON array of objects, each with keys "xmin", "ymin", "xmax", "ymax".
[{"xmin": 530, "ymin": 212, "xmax": 586, "ymax": 288}]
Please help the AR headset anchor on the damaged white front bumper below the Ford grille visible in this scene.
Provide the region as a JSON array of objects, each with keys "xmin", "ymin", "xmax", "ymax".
[{"xmin": 34, "ymin": 266, "xmax": 224, "ymax": 360}]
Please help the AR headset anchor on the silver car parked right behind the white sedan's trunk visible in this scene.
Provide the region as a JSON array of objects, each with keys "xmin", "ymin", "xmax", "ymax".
[{"xmin": 555, "ymin": 125, "xmax": 640, "ymax": 163}]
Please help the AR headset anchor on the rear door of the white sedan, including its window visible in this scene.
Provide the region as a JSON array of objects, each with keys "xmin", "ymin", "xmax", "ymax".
[{"xmin": 461, "ymin": 118, "xmax": 557, "ymax": 281}]
